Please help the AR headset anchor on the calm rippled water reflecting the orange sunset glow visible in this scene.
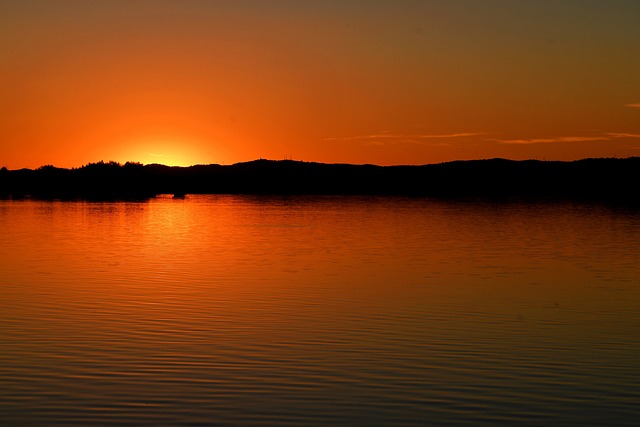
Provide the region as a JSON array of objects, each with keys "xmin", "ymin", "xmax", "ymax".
[{"xmin": 0, "ymin": 196, "xmax": 640, "ymax": 426}]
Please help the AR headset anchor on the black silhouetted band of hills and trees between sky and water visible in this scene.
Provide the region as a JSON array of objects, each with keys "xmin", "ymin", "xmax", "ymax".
[{"xmin": 0, "ymin": 157, "xmax": 640, "ymax": 203}]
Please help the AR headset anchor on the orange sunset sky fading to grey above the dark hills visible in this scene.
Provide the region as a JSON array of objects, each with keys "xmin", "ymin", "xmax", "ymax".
[{"xmin": 0, "ymin": 0, "xmax": 640, "ymax": 169}]
